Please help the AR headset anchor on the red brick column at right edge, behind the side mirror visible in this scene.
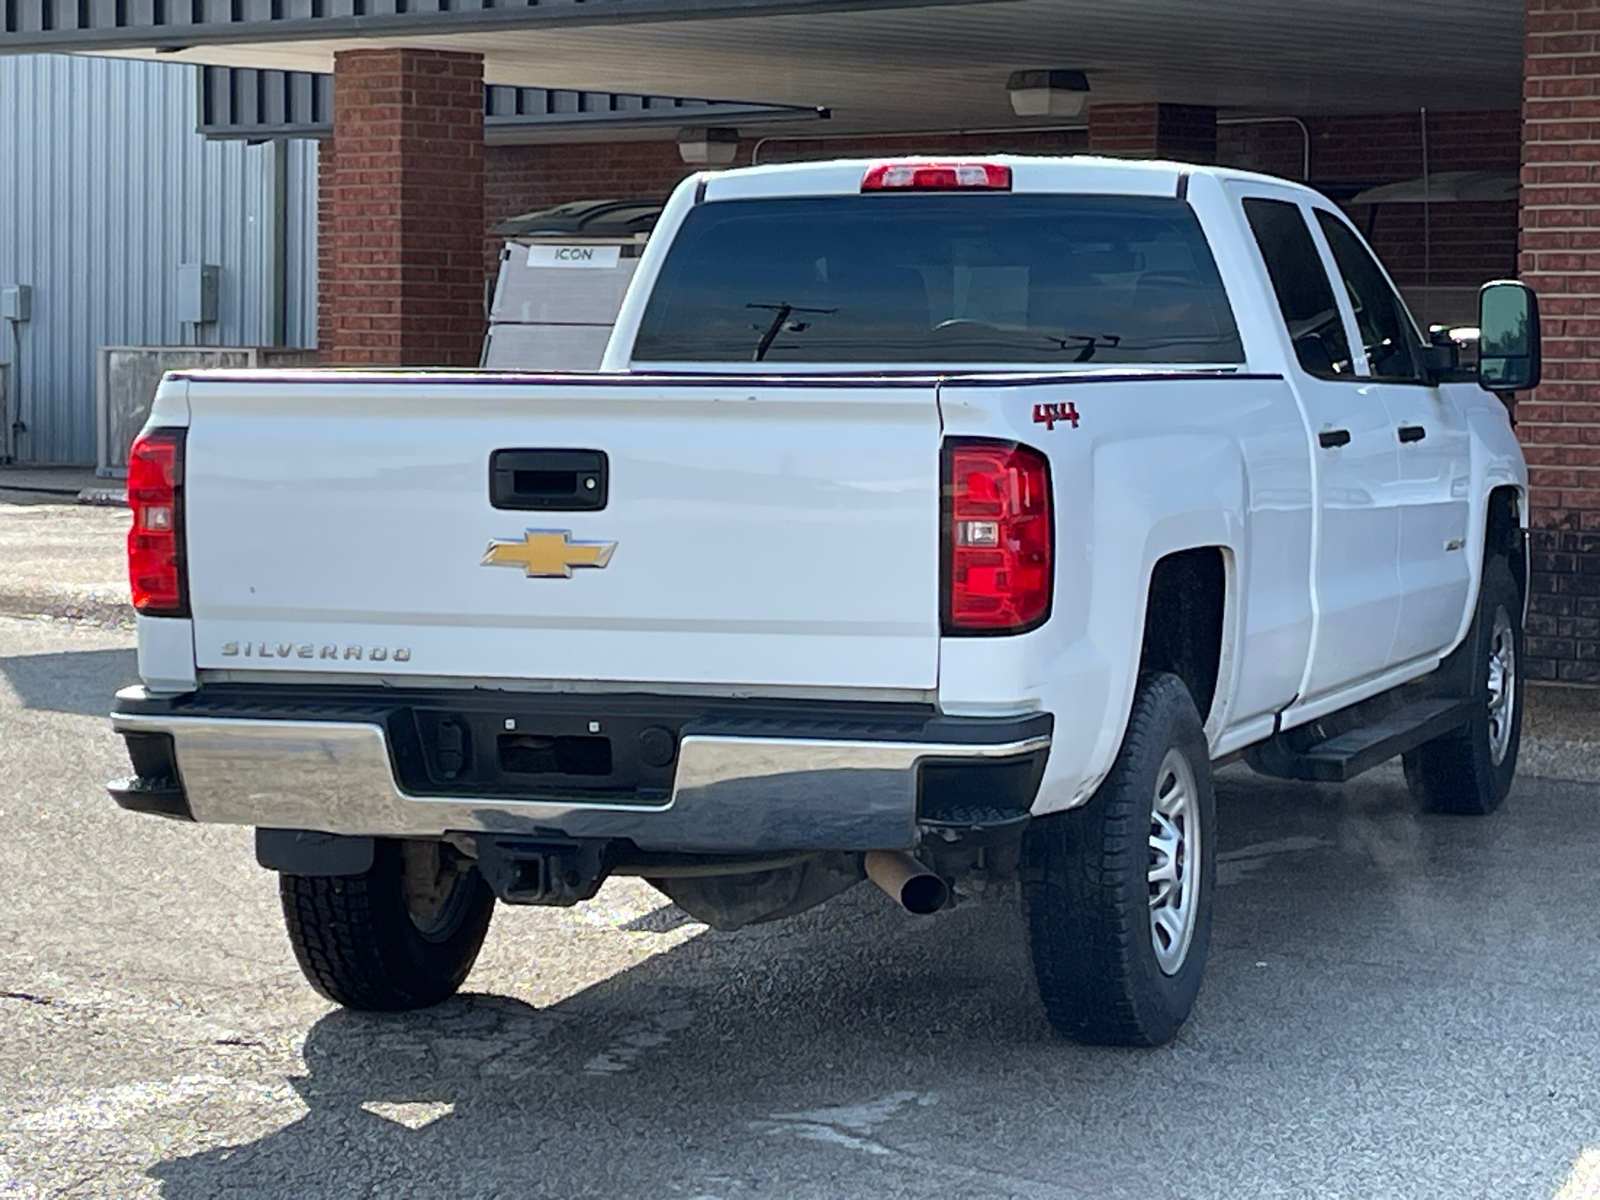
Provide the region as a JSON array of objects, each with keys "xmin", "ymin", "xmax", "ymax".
[{"xmin": 1517, "ymin": 0, "xmax": 1600, "ymax": 683}]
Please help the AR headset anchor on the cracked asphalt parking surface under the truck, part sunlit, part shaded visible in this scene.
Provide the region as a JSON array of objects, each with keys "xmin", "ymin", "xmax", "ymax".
[{"xmin": 0, "ymin": 618, "xmax": 1600, "ymax": 1200}]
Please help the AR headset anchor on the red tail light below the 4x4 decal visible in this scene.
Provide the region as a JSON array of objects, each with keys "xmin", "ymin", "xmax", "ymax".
[{"xmin": 944, "ymin": 438, "xmax": 1056, "ymax": 634}]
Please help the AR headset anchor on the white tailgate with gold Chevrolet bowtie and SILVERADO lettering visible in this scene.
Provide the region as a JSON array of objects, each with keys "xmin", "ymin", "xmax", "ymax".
[{"xmin": 186, "ymin": 374, "xmax": 939, "ymax": 691}]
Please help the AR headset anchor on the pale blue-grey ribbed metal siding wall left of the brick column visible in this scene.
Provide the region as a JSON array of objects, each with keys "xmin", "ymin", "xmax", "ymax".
[{"xmin": 0, "ymin": 54, "xmax": 317, "ymax": 462}]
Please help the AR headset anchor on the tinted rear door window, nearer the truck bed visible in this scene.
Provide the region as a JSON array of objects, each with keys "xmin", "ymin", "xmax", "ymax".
[{"xmin": 1245, "ymin": 200, "xmax": 1354, "ymax": 379}]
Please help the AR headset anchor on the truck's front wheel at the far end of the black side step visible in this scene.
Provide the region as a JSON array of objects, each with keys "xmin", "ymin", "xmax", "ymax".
[{"xmin": 1403, "ymin": 555, "xmax": 1522, "ymax": 816}]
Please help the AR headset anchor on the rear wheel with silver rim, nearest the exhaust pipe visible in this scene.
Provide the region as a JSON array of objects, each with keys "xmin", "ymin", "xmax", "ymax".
[{"xmin": 1022, "ymin": 674, "xmax": 1216, "ymax": 1046}]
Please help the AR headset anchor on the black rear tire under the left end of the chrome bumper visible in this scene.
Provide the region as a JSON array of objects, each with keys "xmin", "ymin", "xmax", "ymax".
[{"xmin": 278, "ymin": 840, "xmax": 494, "ymax": 1013}]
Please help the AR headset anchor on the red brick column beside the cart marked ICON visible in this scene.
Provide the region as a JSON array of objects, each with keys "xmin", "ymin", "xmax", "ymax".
[{"xmin": 318, "ymin": 50, "xmax": 483, "ymax": 366}]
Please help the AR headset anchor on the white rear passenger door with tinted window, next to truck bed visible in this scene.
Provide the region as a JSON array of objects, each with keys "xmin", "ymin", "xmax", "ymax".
[{"xmin": 1243, "ymin": 189, "xmax": 1402, "ymax": 702}]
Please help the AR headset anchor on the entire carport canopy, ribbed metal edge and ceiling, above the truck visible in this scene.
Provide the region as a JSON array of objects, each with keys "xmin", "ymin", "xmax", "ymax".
[{"xmin": 0, "ymin": 0, "xmax": 1522, "ymax": 133}]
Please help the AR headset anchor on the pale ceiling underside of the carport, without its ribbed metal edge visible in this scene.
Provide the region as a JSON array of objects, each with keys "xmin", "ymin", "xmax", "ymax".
[{"xmin": 75, "ymin": 0, "xmax": 1522, "ymax": 134}]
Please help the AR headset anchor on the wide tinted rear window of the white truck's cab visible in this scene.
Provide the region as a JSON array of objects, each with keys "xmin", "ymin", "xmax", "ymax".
[{"xmin": 634, "ymin": 194, "xmax": 1243, "ymax": 365}]
